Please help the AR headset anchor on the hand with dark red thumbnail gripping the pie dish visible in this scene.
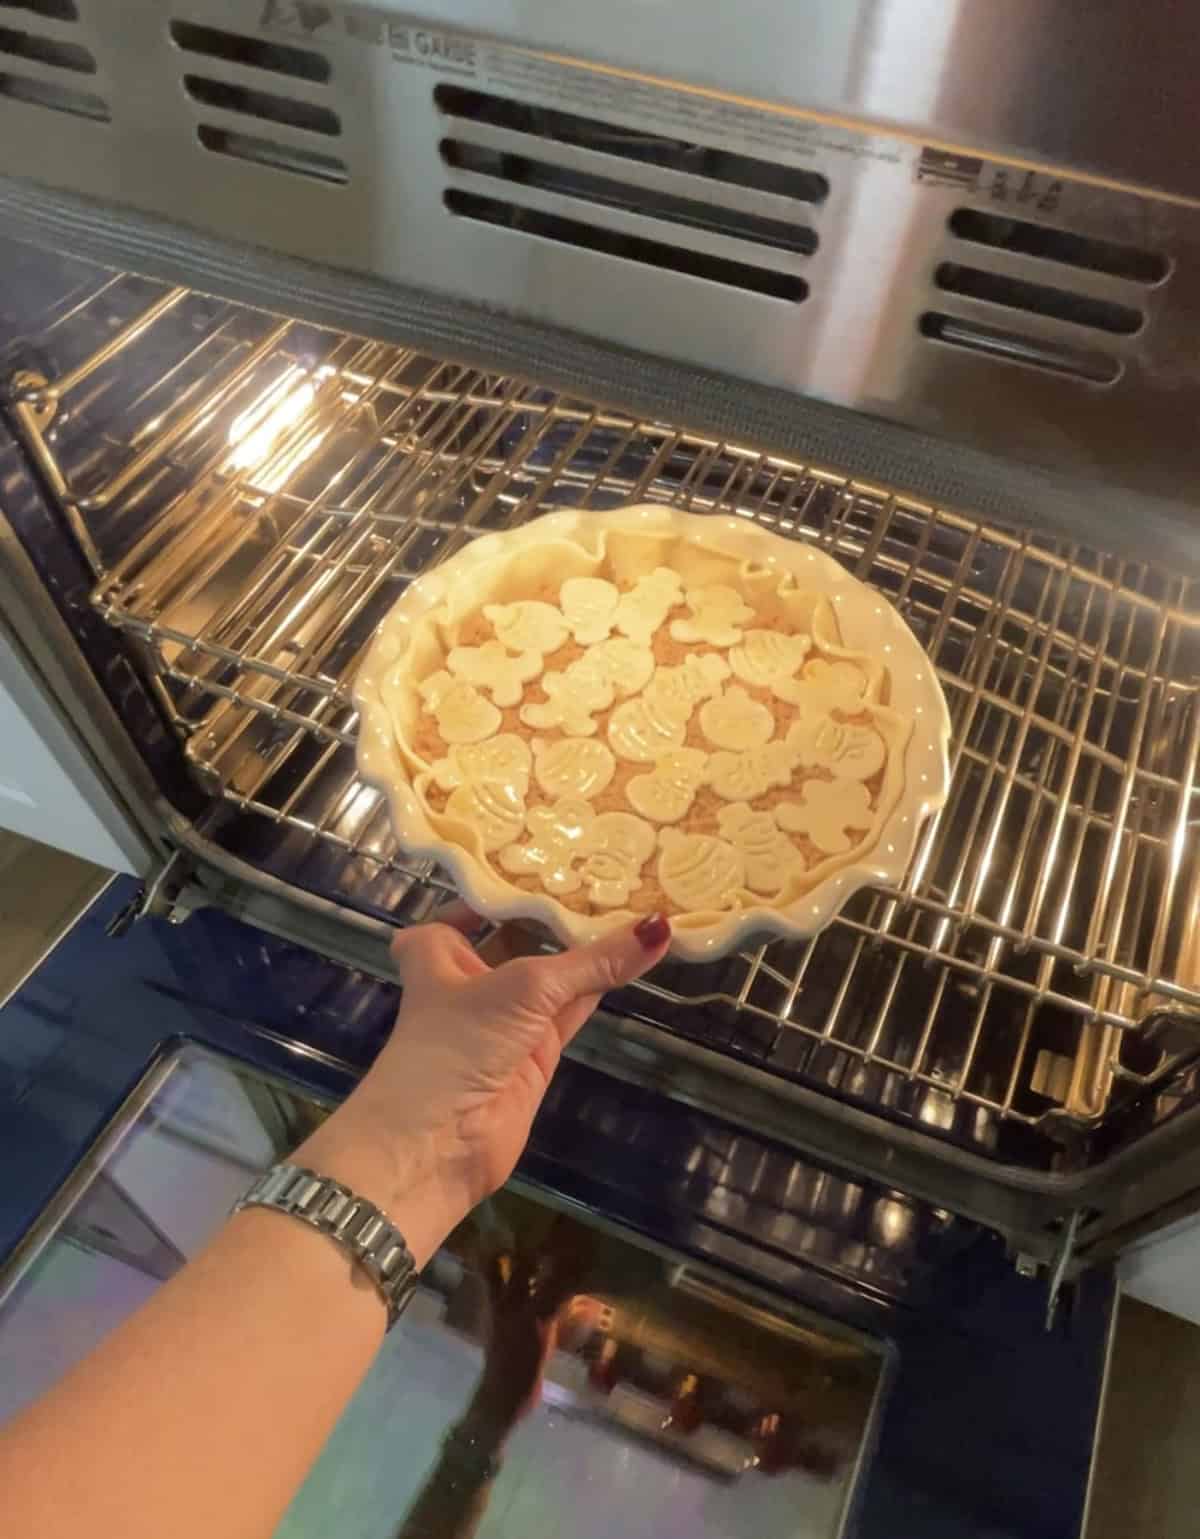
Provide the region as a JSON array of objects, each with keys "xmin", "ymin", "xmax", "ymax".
[{"xmin": 297, "ymin": 903, "xmax": 671, "ymax": 1267}]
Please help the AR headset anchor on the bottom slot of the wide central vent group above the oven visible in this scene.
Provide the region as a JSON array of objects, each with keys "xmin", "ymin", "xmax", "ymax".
[{"xmin": 443, "ymin": 188, "xmax": 808, "ymax": 303}]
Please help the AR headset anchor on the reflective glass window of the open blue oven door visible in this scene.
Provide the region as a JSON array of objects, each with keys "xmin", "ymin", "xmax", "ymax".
[{"xmin": 0, "ymin": 1048, "xmax": 882, "ymax": 1539}]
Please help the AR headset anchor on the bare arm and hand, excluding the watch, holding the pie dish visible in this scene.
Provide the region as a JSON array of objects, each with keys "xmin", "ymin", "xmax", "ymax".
[{"xmin": 0, "ymin": 911, "xmax": 669, "ymax": 1539}]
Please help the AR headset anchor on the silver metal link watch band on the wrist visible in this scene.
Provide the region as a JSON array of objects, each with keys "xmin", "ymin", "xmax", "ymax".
[{"xmin": 234, "ymin": 1165, "xmax": 417, "ymax": 1330}]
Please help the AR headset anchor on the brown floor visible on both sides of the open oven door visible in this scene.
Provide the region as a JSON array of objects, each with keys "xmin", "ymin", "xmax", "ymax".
[{"xmin": 0, "ymin": 830, "xmax": 1200, "ymax": 1539}]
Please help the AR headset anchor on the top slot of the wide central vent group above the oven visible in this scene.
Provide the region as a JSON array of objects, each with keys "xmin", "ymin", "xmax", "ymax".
[{"xmin": 434, "ymin": 85, "xmax": 829, "ymax": 203}]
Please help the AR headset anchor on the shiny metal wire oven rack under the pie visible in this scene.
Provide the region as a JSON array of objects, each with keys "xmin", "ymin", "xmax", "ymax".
[{"xmin": 12, "ymin": 275, "xmax": 1200, "ymax": 1160}]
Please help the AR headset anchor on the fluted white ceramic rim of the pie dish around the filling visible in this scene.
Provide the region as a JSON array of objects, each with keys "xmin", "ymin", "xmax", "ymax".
[{"xmin": 354, "ymin": 503, "xmax": 949, "ymax": 960}]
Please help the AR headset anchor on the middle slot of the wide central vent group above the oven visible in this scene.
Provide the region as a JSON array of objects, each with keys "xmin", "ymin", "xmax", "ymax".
[{"xmin": 440, "ymin": 139, "xmax": 817, "ymax": 257}]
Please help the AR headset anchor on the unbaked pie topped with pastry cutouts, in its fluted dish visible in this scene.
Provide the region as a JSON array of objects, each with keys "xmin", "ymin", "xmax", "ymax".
[{"xmin": 357, "ymin": 505, "xmax": 948, "ymax": 940}]
